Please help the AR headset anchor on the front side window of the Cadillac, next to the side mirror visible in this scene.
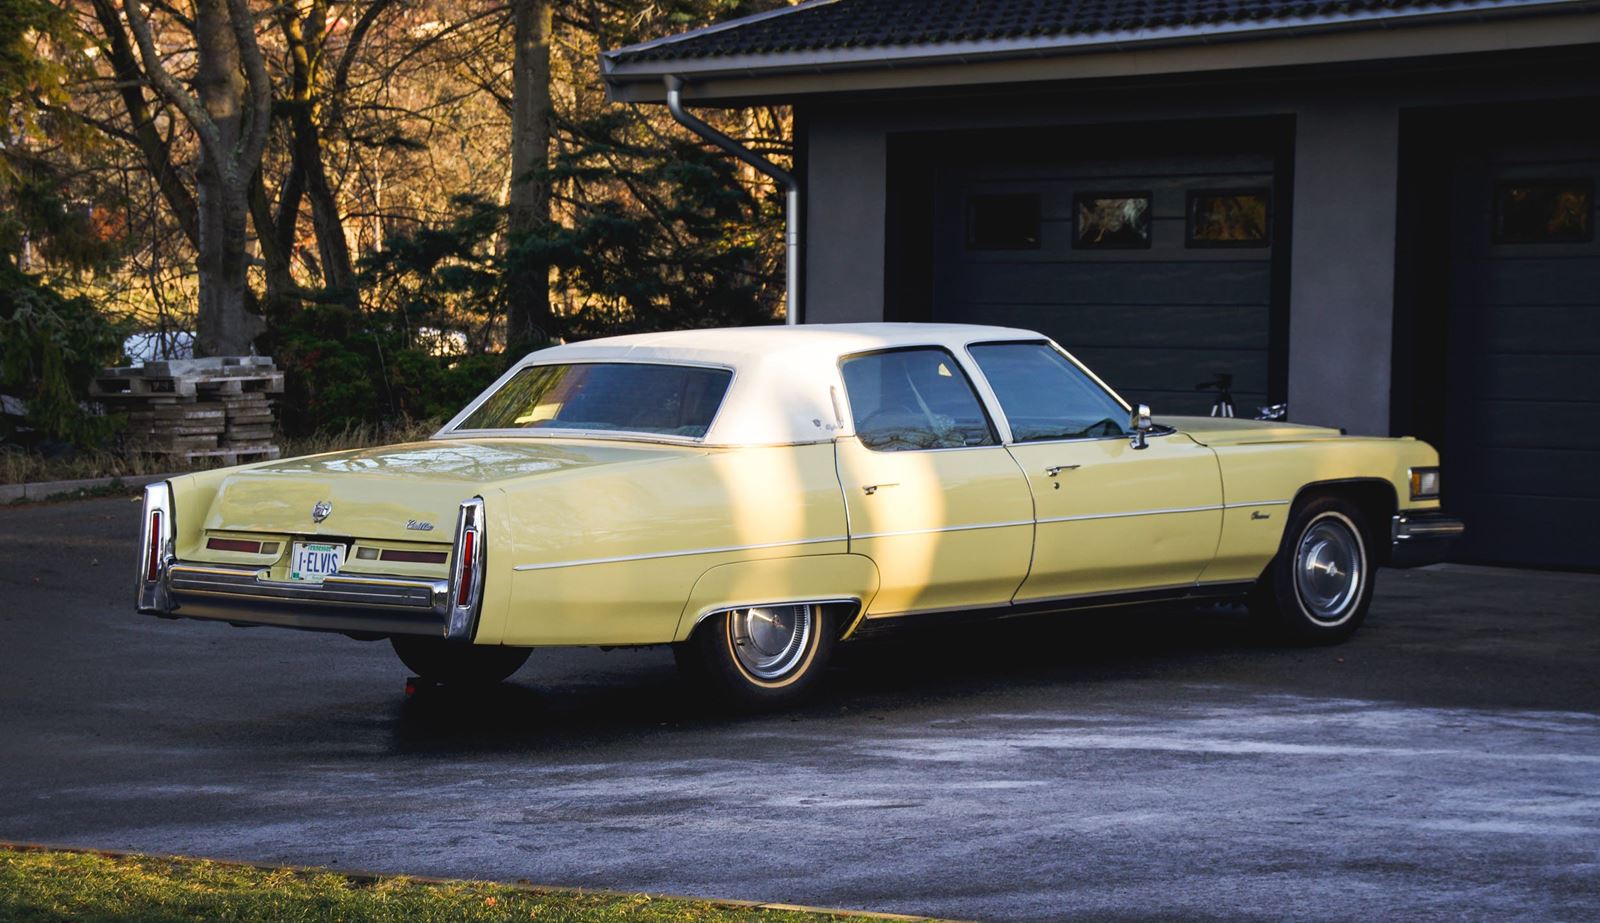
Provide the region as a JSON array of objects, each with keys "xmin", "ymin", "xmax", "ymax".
[{"xmin": 971, "ymin": 342, "xmax": 1128, "ymax": 442}]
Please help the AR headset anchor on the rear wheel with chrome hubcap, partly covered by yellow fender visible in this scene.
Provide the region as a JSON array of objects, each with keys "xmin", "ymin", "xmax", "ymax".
[{"xmin": 672, "ymin": 605, "xmax": 837, "ymax": 712}]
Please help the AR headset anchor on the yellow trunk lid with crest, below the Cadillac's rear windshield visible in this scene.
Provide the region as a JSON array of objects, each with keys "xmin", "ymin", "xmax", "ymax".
[{"xmin": 195, "ymin": 438, "xmax": 704, "ymax": 542}]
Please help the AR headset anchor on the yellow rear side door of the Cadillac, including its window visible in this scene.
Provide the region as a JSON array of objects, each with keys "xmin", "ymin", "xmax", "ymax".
[{"xmin": 835, "ymin": 347, "xmax": 1034, "ymax": 616}]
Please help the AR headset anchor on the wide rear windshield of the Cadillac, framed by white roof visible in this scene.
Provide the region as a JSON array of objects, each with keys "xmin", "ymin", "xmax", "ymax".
[{"xmin": 456, "ymin": 362, "xmax": 733, "ymax": 438}]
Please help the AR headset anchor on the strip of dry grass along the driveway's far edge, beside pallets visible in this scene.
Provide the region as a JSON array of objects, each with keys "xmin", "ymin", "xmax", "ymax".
[{"xmin": 0, "ymin": 421, "xmax": 438, "ymax": 485}]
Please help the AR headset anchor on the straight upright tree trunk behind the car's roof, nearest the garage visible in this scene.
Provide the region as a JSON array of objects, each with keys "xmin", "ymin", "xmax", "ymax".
[{"xmin": 506, "ymin": 0, "xmax": 555, "ymax": 346}]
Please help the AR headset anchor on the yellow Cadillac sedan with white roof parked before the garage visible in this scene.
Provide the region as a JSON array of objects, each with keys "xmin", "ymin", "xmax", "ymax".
[{"xmin": 138, "ymin": 323, "xmax": 1462, "ymax": 707}]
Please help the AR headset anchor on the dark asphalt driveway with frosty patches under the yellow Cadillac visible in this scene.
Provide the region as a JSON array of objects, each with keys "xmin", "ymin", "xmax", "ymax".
[{"xmin": 0, "ymin": 499, "xmax": 1600, "ymax": 920}]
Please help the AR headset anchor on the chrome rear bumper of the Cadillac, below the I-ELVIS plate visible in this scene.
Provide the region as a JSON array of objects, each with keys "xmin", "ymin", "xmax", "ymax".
[{"xmin": 144, "ymin": 561, "xmax": 451, "ymax": 638}]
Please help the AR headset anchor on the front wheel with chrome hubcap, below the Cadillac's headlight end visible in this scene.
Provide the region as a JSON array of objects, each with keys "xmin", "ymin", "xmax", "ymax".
[{"xmin": 1250, "ymin": 497, "xmax": 1376, "ymax": 645}]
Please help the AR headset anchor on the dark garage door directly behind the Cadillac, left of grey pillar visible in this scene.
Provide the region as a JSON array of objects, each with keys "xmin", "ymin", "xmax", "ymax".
[{"xmin": 931, "ymin": 131, "xmax": 1286, "ymax": 416}]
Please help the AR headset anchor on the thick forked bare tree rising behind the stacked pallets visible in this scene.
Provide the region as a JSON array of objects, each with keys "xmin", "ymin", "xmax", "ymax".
[{"xmin": 123, "ymin": 0, "xmax": 272, "ymax": 355}]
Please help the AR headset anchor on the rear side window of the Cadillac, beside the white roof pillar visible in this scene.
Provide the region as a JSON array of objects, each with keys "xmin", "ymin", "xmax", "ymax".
[{"xmin": 842, "ymin": 347, "xmax": 998, "ymax": 451}]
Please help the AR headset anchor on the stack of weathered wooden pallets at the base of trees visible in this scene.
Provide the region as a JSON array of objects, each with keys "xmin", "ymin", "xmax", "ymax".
[{"xmin": 90, "ymin": 357, "xmax": 283, "ymax": 464}]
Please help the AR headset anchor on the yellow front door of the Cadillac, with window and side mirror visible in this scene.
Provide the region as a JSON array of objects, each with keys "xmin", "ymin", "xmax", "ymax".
[{"xmin": 970, "ymin": 342, "xmax": 1222, "ymax": 603}]
